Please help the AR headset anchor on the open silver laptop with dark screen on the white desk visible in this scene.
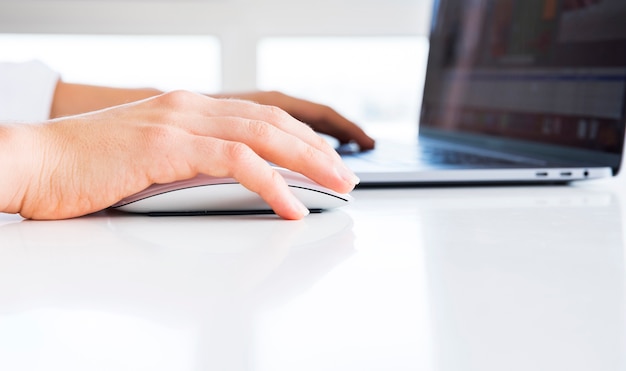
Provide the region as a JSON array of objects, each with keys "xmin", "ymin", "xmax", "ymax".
[{"xmin": 340, "ymin": 0, "xmax": 626, "ymax": 186}]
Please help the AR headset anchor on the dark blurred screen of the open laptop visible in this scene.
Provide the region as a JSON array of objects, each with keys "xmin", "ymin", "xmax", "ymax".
[{"xmin": 420, "ymin": 0, "xmax": 626, "ymax": 158}]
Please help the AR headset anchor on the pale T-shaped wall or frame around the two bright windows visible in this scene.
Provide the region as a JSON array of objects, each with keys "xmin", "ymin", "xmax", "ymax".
[{"xmin": 0, "ymin": 0, "xmax": 431, "ymax": 91}]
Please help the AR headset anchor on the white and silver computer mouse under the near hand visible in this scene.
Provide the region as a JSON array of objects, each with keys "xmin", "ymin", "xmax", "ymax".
[{"xmin": 111, "ymin": 167, "xmax": 353, "ymax": 215}]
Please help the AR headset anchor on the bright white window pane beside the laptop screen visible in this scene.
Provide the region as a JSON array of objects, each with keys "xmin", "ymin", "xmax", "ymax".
[{"xmin": 257, "ymin": 36, "xmax": 428, "ymax": 132}]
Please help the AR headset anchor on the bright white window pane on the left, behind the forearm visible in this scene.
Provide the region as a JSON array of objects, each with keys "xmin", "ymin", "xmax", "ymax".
[{"xmin": 0, "ymin": 34, "xmax": 221, "ymax": 93}]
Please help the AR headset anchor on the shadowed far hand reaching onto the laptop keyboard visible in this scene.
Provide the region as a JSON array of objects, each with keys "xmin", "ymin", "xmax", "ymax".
[{"xmin": 218, "ymin": 92, "xmax": 375, "ymax": 151}]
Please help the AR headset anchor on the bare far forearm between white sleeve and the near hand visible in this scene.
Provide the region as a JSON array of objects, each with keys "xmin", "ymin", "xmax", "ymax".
[{"xmin": 50, "ymin": 81, "xmax": 162, "ymax": 118}]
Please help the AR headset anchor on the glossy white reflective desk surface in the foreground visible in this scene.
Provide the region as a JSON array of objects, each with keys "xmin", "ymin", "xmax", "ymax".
[{"xmin": 0, "ymin": 181, "xmax": 626, "ymax": 371}]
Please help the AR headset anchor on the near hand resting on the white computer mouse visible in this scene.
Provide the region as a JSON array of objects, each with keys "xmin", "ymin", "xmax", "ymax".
[{"xmin": 0, "ymin": 91, "xmax": 358, "ymax": 219}]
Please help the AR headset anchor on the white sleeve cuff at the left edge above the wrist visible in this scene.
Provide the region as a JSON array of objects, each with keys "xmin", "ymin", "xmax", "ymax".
[{"xmin": 0, "ymin": 61, "xmax": 59, "ymax": 122}]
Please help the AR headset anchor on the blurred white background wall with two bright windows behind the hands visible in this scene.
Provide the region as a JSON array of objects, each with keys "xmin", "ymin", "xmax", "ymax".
[{"xmin": 0, "ymin": 0, "xmax": 436, "ymax": 129}]
